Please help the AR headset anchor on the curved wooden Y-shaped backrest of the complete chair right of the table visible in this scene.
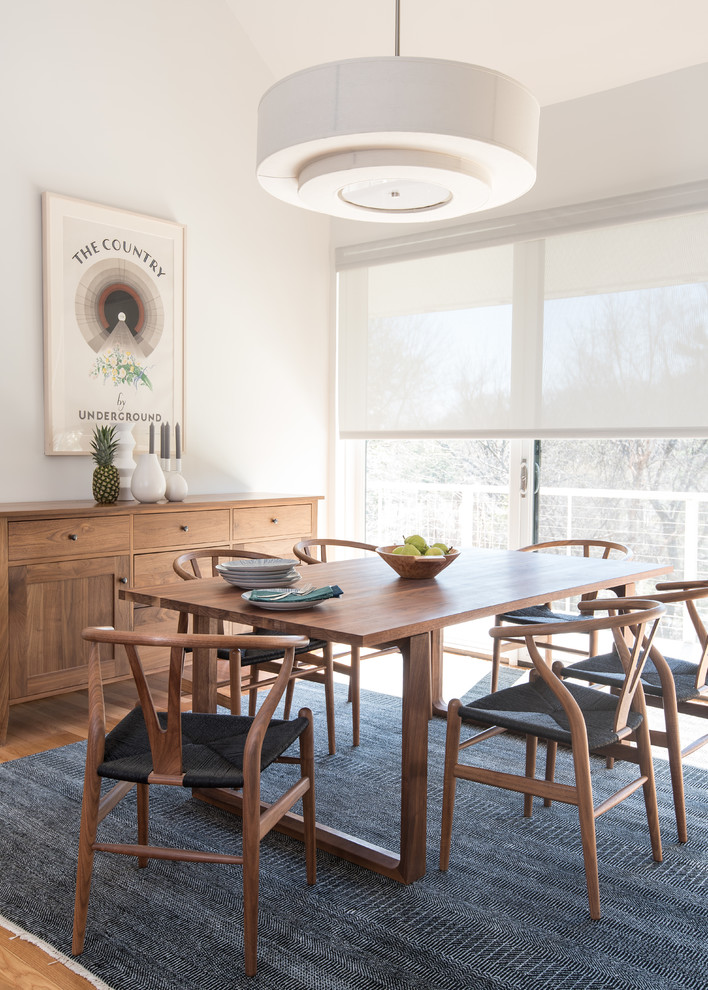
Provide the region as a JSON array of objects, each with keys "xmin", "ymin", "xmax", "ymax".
[{"xmin": 489, "ymin": 598, "xmax": 666, "ymax": 738}]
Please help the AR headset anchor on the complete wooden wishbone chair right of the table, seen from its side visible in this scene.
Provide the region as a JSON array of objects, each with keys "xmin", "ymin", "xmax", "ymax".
[{"xmin": 440, "ymin": 598, "xmax": 665, "ymax": 918}]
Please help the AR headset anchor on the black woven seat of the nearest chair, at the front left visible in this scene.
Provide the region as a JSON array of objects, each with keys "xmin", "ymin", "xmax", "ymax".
[{"xmin": 96, "ymin": 708, "xmax": 307, "ymax": 788}]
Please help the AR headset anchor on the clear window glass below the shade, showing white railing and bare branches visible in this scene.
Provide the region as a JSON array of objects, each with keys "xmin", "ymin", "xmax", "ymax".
[{"xmin": 365, "ymin": 439, "xmax": 708, "ymax": 650}]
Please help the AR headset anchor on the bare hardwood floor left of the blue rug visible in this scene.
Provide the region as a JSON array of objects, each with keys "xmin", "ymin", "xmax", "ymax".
[{"xmin": 0, "ymin": 674, "xmax": 167, "ymax": 990}]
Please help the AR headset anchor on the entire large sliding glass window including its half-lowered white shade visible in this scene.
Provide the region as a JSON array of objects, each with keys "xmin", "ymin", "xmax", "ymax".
[{"xmin": 338, "ymin": 191, "xmax": 708, "ymax": 660}]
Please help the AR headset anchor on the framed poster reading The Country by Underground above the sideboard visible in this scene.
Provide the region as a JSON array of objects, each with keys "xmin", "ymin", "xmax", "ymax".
[{"xmin": 42, "ymin": 192, "xmax": 185, "ymax": 454}]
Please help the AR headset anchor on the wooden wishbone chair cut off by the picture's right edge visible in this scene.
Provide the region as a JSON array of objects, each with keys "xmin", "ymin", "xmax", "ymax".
[{"xmin": 553, "ymin": 581, "xmax": 708, "ymax": 842}]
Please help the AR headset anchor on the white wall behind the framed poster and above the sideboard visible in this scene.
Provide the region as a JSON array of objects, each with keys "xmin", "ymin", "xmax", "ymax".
[{"xmin": 0, "ymin": 0, "xmax": 331, "ymax": 501}]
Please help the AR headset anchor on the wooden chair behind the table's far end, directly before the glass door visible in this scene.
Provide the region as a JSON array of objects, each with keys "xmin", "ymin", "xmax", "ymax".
[{"xmin": 492, "ymin": 539, "xmax": 633, "ymax": 691}]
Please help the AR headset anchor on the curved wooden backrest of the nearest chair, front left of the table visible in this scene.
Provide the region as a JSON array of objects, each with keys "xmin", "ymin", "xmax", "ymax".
[{"xmin": 81, "ymin": 626, "xmax": 308, "ymax": 784}]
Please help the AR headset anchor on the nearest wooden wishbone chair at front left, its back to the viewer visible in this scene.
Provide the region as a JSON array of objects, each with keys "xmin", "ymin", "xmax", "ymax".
[{"xmin": 71, "ymin": 627, "xmax": 316, "ymax": 976}]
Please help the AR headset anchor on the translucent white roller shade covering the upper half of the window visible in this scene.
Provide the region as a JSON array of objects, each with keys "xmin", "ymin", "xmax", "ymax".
[{"xmin": 339, "ymin": 205, "xmax": 708, "ymax": 438}]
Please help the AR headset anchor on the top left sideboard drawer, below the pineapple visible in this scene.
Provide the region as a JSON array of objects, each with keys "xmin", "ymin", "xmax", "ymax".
[{"xmin": 8, "ymin": 515, "xmax": 130, "ymax": 561}]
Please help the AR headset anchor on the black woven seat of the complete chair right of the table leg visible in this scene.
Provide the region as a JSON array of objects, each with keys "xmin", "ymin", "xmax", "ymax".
[{"xmin": 460, "ymin": 680, "xmax": 642, "ymax": 750}]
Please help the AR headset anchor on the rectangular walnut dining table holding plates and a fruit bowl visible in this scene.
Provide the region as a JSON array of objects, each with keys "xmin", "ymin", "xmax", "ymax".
[{"xmin": 120, "ymin": 549, "xmax": 671, "ymax": 883}]
